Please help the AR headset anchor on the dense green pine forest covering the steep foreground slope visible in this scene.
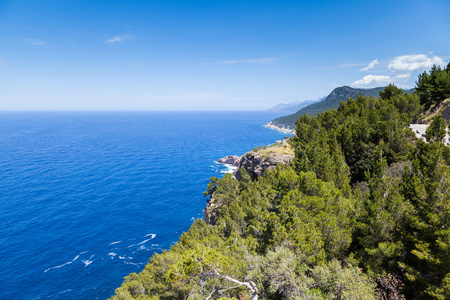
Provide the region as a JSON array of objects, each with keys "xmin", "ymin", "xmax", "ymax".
[{"xmin": 111, "ymin": 64, "xmax": 450, "ymax": 300}]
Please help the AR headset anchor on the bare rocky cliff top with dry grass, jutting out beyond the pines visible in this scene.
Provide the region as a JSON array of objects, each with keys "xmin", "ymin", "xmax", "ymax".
[{"xmin": 235, "ymin": 151, "xmax": 294, "ymax": 180}]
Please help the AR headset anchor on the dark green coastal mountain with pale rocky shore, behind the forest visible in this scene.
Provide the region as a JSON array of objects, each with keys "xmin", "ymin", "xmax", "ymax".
[{"xmin": 267, "ymin": 86, "xmax": 415, "ymax": 131}]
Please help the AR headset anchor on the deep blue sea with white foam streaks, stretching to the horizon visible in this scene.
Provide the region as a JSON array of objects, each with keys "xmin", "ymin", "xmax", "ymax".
[{"xmin": 0, "ymin": 112, "xmax": 286, "ymax": 299}]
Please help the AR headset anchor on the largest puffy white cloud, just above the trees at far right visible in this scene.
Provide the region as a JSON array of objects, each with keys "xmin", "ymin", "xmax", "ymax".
[{"xmin": 387, "ymin": 54, "xmax": 446, "ymax": 73}]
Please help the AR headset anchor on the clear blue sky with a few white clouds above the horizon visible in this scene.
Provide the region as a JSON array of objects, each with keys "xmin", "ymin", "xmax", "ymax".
[{"xmin": 0, "ymin": 0, "xmax": 450, "ymax": 110}]
